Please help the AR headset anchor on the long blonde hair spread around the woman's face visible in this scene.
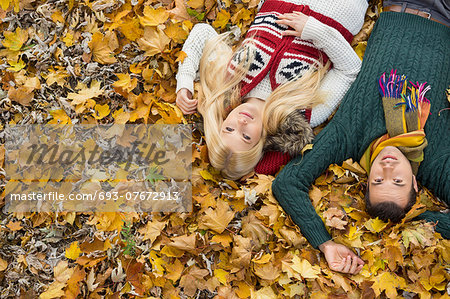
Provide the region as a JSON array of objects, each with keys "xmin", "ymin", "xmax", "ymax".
[{"xmin": 198, "ymin": 33, "xmax": 330, "ymax": 180}]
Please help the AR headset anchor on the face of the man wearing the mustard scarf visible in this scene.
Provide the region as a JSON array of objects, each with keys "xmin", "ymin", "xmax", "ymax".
[{"xmin": 368, "ymin": 146, "xmax": 417, "ymax": 208}]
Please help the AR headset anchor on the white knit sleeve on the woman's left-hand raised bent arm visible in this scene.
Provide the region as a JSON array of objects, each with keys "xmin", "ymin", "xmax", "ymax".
[{"xmin": 176, "ymin": 24, "xmax": 218, "ymax": 93}]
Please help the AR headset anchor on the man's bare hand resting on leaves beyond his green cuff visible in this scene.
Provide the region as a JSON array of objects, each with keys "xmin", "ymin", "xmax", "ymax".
[{"xmin": 319, "ymin": 240, "xmax": 364, "ymax": 274}]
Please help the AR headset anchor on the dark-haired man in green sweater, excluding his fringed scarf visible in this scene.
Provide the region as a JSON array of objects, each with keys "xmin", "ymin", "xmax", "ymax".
[{"xmin": 272, "ymin": 0, "xmax": 450, "ymax": 273}]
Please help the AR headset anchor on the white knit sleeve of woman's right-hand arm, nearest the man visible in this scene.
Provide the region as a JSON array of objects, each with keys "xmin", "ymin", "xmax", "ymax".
[{"xmin": 302, "ymin": 17, "xmax": 361, "ymax": 127}]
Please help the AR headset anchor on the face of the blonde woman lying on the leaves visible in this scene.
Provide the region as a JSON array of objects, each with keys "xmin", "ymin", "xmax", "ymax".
[{"xmin": 220, "ymin": 100, "xmax": 263, "ymax": 152}]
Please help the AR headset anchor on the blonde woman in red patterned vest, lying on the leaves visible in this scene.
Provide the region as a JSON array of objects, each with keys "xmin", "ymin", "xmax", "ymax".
[{"xmin": 176, "ymin": 0, "xmax": 367, "ymax": 179}]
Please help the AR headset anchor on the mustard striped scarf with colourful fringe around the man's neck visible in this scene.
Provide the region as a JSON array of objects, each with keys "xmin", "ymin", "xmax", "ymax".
[{"xmin": 360, "ymin": 70, "xmax": 430, "ymax": 174}]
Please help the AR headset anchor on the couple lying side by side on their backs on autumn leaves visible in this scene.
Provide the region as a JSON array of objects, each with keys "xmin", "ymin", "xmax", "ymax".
[{"xmin": 177, "ymin": 0, "xmax": 450, "ymax": 274}]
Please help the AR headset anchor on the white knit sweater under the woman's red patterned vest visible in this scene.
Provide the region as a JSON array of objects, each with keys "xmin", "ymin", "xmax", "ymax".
[{"xmin": 176, "ymin": 0, "xmax": 368, "ymax": 127}]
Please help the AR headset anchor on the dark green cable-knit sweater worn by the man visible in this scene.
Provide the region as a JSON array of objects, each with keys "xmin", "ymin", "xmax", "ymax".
[{"xmin": 272, "ymin": 12, "xmax": 450, "ymax": 248}]
